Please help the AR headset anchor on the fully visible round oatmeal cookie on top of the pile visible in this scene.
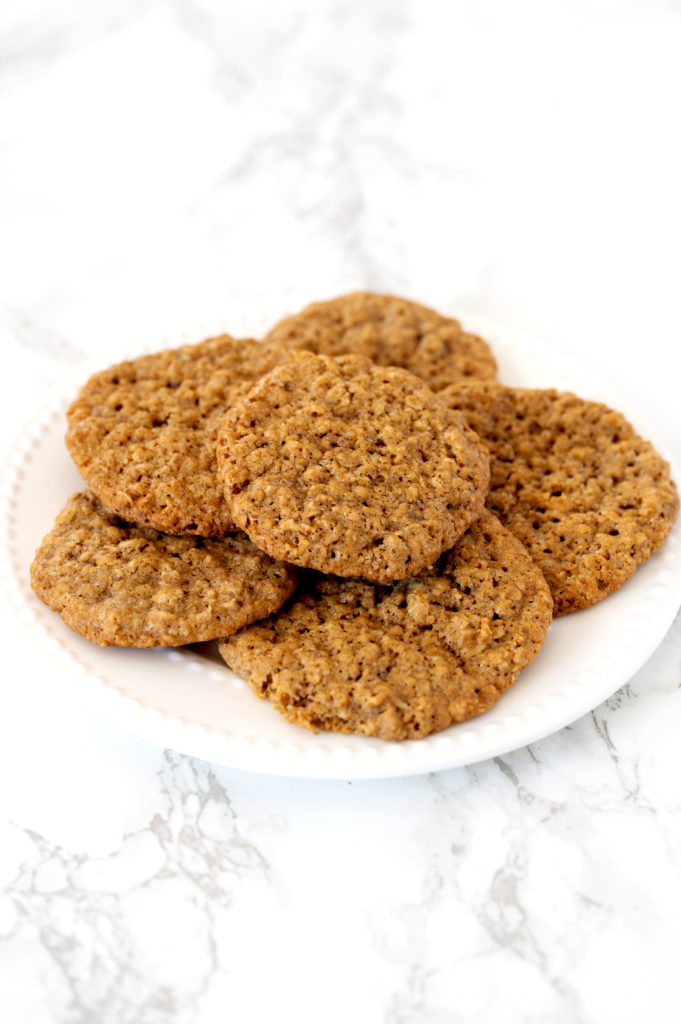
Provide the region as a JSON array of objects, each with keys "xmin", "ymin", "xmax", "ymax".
[{"xmin": 217, "ymin": 352, "xmax": 488, "ymax": 582}]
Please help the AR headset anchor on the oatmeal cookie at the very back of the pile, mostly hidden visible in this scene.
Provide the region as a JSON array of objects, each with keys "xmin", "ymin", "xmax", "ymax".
[{"xmin": 264, "ymin": 292, "xmax": 497, "ymax": 391}]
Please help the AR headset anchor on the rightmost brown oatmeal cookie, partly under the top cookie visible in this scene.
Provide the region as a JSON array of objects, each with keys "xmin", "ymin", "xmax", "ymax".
[{"xmin": 439, "ymin": 382, "xmax": 679, "ymax": 614}]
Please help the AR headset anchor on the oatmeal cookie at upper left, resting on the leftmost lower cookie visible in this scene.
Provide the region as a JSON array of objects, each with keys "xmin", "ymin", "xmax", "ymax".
[{"xmin": 67, "ymin": 335, "xmax": 276, "ymax": 537}]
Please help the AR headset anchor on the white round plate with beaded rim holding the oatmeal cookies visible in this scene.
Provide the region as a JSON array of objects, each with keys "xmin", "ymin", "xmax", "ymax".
[{"xmin": 0, "ymin": 316, "xmax": 681, "ymax": 778}]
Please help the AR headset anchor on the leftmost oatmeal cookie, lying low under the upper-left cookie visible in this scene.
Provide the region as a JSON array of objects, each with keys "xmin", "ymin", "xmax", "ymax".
[{"xmin": 31, "ymin": 492, "xmax": 296, "ymax": 647}]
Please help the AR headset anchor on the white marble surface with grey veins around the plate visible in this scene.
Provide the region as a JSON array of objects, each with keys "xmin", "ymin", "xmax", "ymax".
[{"xmin": 0, "ymin": 0, "xmax": 681, "ymax": 1024}]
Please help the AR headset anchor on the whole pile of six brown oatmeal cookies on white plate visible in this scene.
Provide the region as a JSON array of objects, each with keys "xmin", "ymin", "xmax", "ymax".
[{"xmin": 31, "ymin": 293, "xmax": 679, "ymax": 740}]
